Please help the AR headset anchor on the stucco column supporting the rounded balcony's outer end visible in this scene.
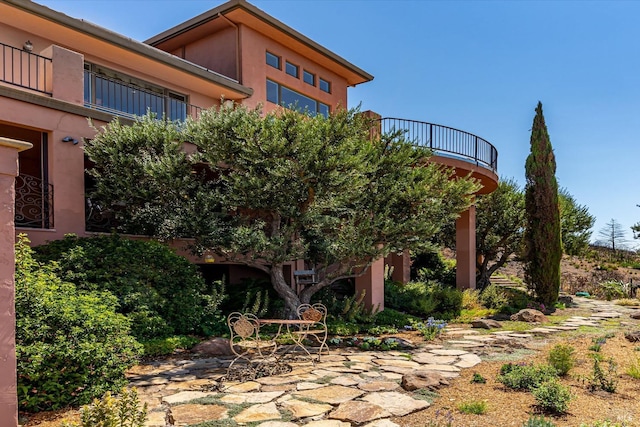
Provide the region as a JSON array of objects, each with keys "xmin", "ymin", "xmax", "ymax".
[{"xmin": 456, "ymin": 206, "xmax": 476, "ymax": 289}]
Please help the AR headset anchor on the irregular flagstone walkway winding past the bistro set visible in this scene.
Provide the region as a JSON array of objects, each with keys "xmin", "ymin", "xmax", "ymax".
[{"xmin": 129, "ymin": 298, "xmax": 631, "ymax": 427}]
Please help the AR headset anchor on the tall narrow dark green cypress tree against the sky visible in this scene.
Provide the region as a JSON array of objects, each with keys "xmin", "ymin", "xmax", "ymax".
[{"xmin": 525, "ymin": 102, "xmax": 562, "ymax": 309}]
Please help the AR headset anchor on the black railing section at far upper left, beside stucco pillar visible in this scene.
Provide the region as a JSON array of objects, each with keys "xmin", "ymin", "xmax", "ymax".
[{"xmin": 0, "ymin": 43, "xmax": 52, "ymax": 95}]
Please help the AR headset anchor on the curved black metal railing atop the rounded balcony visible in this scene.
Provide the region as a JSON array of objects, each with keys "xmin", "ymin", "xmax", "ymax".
[{"xmin": 380, "ymin": 118, "xmax": 498, "ymax": 172}]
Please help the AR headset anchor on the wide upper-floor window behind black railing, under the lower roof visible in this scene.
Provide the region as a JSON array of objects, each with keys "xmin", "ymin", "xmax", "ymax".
[{"xmin": 84, "ymin": 63, "xmax": 188, "ymax": 120}]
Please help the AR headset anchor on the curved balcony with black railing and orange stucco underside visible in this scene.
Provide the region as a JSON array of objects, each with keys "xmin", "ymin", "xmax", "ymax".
[{"xmin": 380, "ymin": 117, "xmax": 498, "ymax": 194}]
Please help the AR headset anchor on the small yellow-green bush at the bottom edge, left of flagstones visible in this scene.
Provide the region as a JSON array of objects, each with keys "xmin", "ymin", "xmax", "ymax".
[{"xmin": 62, "ymin": 388, "xmax": 147, "ymax": 427}]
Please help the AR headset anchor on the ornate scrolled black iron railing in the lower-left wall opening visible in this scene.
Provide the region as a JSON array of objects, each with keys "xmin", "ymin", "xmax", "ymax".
[{"xmin": 15, "ymin": 175, "xmax": 53, "ymax": 229}]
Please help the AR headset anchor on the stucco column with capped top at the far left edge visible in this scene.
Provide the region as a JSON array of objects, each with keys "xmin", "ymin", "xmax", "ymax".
[{"xmin": 0, "ymin": 138, "xmax": 32, "ymax": 427}]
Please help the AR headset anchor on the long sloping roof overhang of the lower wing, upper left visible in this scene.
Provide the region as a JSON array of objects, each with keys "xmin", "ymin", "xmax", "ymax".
[{"xmin": 0, "ymin": 0, "xmax": 253, "ymax": 100}]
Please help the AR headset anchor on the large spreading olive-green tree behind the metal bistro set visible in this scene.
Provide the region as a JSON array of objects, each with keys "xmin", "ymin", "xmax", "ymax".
[{"xmin": 86, "ymin": 106, "xmax": 478, "ymax": 312}]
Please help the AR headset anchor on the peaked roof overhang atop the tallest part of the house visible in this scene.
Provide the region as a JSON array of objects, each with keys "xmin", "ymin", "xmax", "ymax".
[{"xmin": 145, "ymin": 0, "xmax": 373, "ymax": 86}]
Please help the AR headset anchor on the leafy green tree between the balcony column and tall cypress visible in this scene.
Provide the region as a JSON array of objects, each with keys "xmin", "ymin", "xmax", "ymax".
[{"xmin": 476, "ymin": 179, "xmax": 525, "ymax": 289}]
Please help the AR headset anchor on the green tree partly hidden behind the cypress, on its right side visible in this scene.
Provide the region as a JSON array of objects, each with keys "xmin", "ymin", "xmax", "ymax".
[{"xmin": 558, "ymin": 188, "xmax": 596, "ymax": 255}]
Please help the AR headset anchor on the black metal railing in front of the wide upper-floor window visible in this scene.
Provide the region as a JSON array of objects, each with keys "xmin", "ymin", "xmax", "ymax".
[{"xmin": 84, "ymin": 70, "xmax": 202, "ymax": 120}]
